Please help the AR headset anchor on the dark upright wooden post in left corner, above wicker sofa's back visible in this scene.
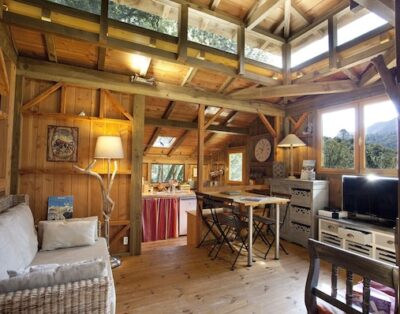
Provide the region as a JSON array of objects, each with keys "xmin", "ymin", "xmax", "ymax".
[{"xmin": 10, "ymin": 75, "xmax": 24, "ymax": 194}]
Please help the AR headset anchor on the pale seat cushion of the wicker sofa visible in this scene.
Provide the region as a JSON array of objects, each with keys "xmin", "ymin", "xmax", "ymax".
[{"xmin": 31, "ymin": 238, "xmax": 116, "ymax": 313}]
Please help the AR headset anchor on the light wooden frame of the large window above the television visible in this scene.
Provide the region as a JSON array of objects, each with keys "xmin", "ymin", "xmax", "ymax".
[{"xmin": 316, "ymin": 96, "xmax": 399, "ymax": 177}]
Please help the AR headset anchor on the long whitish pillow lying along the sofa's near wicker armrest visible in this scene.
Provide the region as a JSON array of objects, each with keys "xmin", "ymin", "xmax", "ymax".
[{"xmin": 0, "ymin": 259, "xmax": 106, "ymax": 293}]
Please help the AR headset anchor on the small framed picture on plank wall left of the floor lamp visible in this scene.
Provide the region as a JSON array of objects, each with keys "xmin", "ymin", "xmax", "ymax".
[{"xmin": 47, "ymin": 125, "xmax": 79, "ymax": 162}]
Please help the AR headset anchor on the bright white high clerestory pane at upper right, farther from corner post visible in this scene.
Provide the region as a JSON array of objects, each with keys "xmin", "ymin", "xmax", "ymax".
[{"xmin": 338, "ymin": 12, "xmax": 387, "ymax": 46}]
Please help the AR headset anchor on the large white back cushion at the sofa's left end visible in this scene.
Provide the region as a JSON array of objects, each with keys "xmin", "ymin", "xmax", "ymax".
[{"xmin": 0, "ymin": 204, "xmax": 38, "ymax": 280}]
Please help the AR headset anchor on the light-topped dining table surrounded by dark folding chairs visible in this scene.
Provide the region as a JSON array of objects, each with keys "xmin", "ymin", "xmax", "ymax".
[{"xmin": 202, "ymin": 191, "xmax": 290, "ymax": 266}]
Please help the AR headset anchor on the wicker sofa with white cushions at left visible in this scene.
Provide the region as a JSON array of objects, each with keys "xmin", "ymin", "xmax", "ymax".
[{"xmin": 0, "ymin": 195, "xmax": 116, "ymax": 313}]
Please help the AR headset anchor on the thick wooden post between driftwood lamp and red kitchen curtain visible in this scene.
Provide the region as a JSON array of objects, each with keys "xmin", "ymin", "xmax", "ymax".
[{"xmin": 129, "ymin": 95, "xmax": 146, "ymax": 255}]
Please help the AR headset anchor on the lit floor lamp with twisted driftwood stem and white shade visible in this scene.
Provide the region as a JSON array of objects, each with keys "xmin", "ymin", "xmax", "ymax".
[{"xmin": 74, "ymin": 136, "xmax": 124, "ymax": 268}]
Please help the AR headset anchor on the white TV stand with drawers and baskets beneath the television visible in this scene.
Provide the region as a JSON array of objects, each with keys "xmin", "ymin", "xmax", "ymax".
[{"xmin": 318, "ymin": 216, "xmax": 396, "ymax": 264}]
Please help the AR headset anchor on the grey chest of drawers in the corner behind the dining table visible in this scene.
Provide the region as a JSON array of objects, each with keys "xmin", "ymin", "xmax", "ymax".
[{"xmin": 265, "ymin": 179, "xmax": 329, "ymax": 247}]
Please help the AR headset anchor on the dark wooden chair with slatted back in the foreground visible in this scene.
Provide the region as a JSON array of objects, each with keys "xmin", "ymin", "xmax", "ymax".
[{"xmin": 305, "ymin": 239, "xmax": 399, "ymax": 314}]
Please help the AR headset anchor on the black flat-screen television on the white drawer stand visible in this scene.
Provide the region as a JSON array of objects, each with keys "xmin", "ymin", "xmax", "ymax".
[{"xmin": 342, "ymin": 176, "xmax": 398, "ymax": 227}]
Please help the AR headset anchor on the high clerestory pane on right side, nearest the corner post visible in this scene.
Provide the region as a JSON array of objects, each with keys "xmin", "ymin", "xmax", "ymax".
[{"xmin": 291, "ymin": 22, "xmax": 329, "ymax": 68}]
